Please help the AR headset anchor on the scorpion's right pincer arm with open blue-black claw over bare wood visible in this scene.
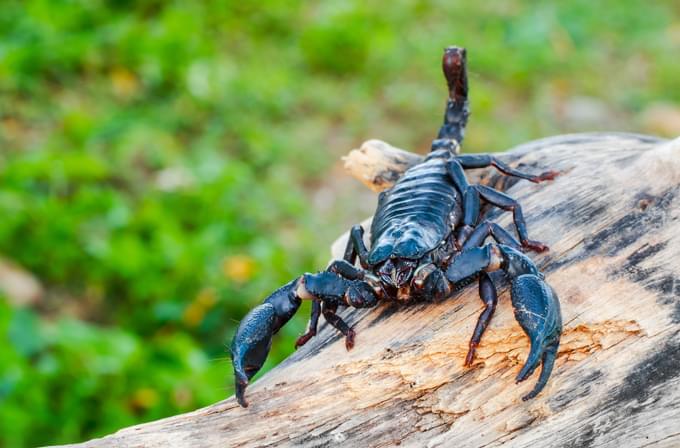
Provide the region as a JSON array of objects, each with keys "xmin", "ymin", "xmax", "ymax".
[{"xmin": 446, "ymin": 243, "xmax": 562, "ymax": 400}]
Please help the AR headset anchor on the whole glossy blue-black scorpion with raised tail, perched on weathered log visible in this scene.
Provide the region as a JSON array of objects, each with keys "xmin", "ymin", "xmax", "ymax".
[{"xmin": 231, "ymin": 47, "xmax": 562, "ymax": 407}]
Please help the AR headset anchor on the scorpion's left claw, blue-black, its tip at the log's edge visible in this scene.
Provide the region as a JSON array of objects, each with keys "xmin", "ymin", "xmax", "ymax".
[{"xmin": 231, "ymin": 279, "xmax": 301, "ymax": 408}]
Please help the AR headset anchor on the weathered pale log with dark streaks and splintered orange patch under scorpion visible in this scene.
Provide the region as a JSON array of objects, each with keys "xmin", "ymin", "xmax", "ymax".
[{"xmin": 61, "ymin": 134, "xmax": 680, "ymax": 448}]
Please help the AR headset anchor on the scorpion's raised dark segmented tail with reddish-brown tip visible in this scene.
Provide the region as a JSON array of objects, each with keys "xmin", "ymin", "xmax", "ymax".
[{"xmin": 432, "ymin": 47, "xmax": 470, "ymax": 154}]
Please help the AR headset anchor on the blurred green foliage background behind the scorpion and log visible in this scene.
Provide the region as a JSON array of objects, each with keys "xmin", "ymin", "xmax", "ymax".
[{"xmin": 0, "ymin": 0, "xmax": 680, "ymax": 447}]
